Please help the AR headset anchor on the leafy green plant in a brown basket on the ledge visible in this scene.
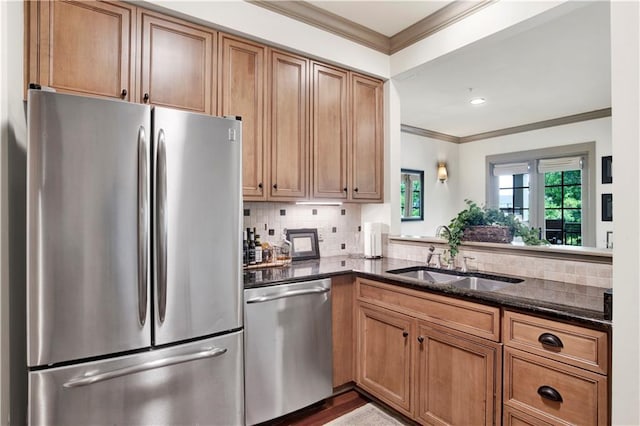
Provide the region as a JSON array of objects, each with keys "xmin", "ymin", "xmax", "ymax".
[{"xmin": 438, "ymin": 200, "xmax": 547, "ymax": 257}]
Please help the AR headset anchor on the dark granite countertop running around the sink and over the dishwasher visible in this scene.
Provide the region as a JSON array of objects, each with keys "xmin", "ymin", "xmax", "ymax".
[{"xmin": 244, "ymin": 256, "xmax": 611, "ymax": 328}]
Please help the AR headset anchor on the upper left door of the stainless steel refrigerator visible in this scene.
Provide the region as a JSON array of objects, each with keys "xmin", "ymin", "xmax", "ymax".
[{"xmin": 27, "ymin": 91, "xmax": 151, "ymax": 366}]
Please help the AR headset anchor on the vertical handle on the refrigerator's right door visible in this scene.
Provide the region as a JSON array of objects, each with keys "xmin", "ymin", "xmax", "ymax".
[{"xmin": 156, "ymin": 129, "xmax": 167, "ymax": 323}]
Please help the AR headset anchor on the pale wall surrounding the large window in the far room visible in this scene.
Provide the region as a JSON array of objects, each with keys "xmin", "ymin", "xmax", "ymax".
[{"xmin": 459, "ymin": 117, "xmax": 613, "ymax": 247}]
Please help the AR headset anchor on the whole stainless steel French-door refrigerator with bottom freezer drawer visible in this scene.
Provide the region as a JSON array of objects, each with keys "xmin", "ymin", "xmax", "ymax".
[{"xmin": 27, "ymin": 90, "xmax": 244, "ymax": 425}]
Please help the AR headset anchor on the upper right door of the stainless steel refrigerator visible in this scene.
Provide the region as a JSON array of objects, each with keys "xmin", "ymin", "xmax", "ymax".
[{"xmin": 154, "ymin": 107, "xmax": 242, "ymax": 344}]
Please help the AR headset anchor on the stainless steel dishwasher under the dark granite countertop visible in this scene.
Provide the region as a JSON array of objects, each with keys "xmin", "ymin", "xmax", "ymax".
[{"xmin": 244, "ymin": 279, "xmax": 333, "ymax": 425}]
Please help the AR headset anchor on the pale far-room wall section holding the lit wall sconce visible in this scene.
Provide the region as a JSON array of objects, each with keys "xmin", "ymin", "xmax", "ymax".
[{"xmin": 396, "ymin": 133, "xmax": 466, "ymax": 236}]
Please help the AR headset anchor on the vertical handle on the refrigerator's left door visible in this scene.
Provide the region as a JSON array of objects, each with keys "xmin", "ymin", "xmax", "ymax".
[{"xmin": 138, "ymin": 126, "xmax": 149, "ymax": 326}]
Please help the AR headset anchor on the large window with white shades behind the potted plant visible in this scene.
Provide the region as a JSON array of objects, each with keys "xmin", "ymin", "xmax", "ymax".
[{"xmin": 487, "ymin": 143, "xmax": 595, "ymax": 246}]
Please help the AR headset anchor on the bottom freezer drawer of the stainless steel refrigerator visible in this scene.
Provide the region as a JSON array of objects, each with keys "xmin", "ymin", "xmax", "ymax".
[{"xmin": 29, "ymin": 331, "xmax": 244, "ymax": 425}]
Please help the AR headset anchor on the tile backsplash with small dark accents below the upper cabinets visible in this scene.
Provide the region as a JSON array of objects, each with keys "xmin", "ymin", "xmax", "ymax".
[{"xmin": 243, "ymin": 202, "xmax": 362, "ymax": 257}]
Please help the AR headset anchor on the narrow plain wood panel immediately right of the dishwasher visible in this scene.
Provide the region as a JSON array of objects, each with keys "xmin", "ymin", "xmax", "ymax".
[{"xmin": 331, "ymin": 274, "xmax": 355, "ymax": 388}]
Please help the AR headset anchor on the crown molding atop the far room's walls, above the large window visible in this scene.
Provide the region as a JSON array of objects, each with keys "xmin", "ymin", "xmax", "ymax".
[{"xmin": 400, "ymin": 108, "xmax": 611, "ymax": 143}]
